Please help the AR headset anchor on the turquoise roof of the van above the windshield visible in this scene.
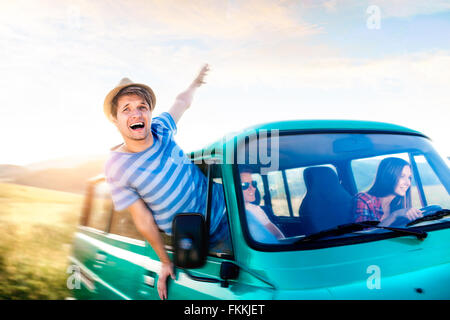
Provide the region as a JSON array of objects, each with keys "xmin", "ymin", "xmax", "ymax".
[{"xmin": 188, "ymin": 120, "xmax": 427, "ymax": 160}]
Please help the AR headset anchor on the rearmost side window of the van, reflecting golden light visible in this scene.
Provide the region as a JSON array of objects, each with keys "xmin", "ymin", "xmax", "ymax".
[{"xmin": 87, "ymin": 181, "xmax": 113, "ymax": 232}]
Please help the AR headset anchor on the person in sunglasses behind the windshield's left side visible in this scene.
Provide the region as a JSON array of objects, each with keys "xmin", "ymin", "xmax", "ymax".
[{"xmin": 240, "ymin": 172, "xmax": 284, "ymax": 243}]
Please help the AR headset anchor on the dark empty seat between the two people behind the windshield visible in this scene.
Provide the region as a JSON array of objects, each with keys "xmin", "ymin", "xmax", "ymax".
[{"xmin": 299, "ymin": 167, "xmax": 353, "ymax": 234}]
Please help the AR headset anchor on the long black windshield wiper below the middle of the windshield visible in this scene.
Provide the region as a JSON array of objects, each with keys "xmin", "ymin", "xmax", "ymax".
[{"xmin": 295, "ymin": 220, "xmax": 428, "ymax": 243}]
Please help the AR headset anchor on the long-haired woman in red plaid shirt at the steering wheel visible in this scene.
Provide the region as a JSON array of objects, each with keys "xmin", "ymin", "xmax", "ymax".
[{"xmin": 355, "ymin": 157, "xmax": 422, "ymax": 226}]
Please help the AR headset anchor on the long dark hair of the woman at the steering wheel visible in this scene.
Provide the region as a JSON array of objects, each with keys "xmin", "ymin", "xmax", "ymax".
[{"xmin": 367, "ymin": 157, "xmax": 411, "ymax": 212}]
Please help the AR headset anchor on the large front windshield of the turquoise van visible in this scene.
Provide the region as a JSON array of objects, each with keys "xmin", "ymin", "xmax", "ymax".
[{"xmin": 235, "ymin": 133, "xmax": 450, "ymax": 245}]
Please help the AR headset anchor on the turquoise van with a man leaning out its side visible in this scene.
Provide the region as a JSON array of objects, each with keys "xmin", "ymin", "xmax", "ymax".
[{"xmin": 68, "ymin": 120, "xmax": 450, "ymax": 300}]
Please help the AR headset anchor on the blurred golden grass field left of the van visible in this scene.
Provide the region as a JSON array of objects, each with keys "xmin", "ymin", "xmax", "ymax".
[{"xmin": 0, "ymin": 183, "xmax": 83, "ymax": 299}]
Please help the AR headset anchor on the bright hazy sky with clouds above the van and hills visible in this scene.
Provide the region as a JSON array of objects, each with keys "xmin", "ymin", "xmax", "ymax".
[{"xmin": 0, "ymin": 0, "xmax": 450, "ymax": 165}]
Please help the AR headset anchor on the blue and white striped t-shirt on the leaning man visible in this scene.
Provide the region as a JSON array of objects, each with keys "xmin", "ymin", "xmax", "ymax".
[{"xmin": 105, "ymin": 112, "xmax": 226, "ymax": 239}]
